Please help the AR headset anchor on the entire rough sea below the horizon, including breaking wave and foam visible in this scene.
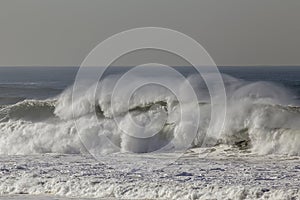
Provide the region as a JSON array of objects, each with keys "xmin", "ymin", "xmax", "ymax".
[{"xmin": 0, "ymin": 67, "xmax": 300, "ymax": 199}]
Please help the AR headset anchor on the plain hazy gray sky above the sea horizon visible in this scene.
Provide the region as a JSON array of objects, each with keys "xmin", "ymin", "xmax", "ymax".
[{"xmin": 0, "ymin": 0, "xmax": 300, "ymax": 66}]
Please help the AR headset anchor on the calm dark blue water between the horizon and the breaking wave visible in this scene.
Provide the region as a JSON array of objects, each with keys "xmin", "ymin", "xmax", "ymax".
[{"xmin": 0, "ymin": 66, "xmax": 300, "ymax": 104}]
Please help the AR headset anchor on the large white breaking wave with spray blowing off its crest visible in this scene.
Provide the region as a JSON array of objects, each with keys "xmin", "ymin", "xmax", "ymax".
[{"xmin": 0, "ymin": 72, "xmax": 300, "ymax": 155}]
